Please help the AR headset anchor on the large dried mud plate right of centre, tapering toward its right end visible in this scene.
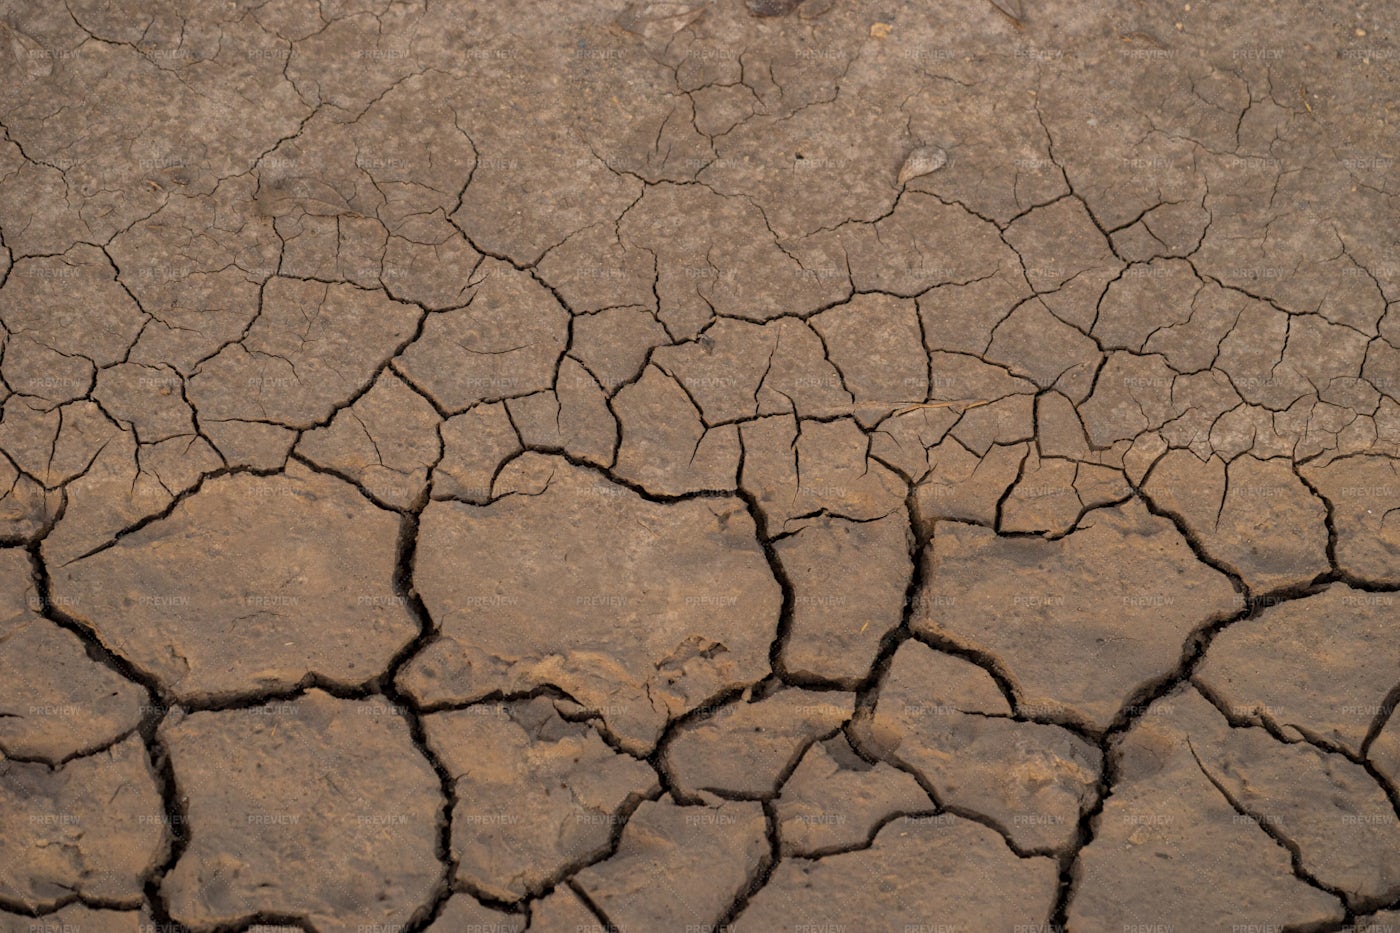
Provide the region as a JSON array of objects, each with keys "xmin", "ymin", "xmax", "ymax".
[{"xmin": 911, "ymin": 502, "xmax": 1238, "ymax": 728}]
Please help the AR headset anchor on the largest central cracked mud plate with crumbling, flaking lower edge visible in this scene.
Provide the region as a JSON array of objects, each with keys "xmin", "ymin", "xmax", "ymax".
[{"xmin": 400, "ymin": 454, "xmax": 781, "ymax": 751}]
